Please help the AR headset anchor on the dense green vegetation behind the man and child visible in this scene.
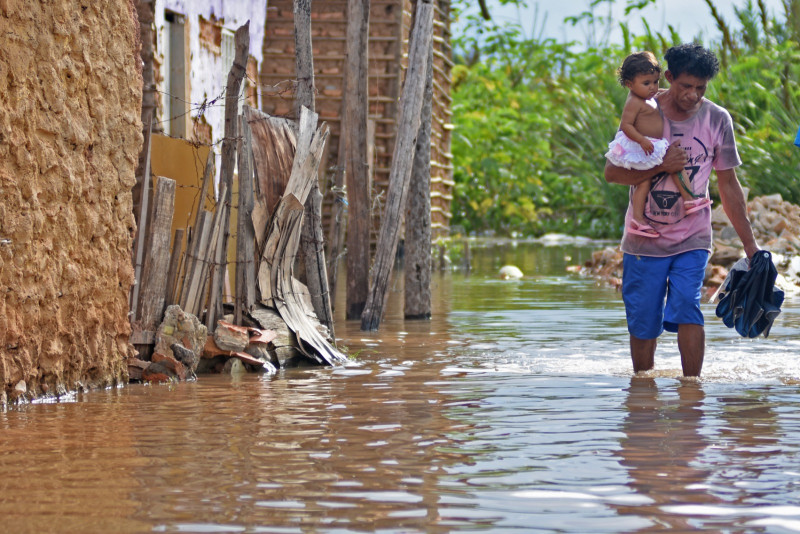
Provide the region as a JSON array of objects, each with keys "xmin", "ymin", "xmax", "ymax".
[{"xmin": 452, "ymin": 0, "xmax": 800, "ymax": 237}]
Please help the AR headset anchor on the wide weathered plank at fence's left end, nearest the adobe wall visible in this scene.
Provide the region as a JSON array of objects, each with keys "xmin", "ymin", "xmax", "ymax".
[{"xmin": 139, "ymin": 176, "xmax": 175, "ymax": 330}]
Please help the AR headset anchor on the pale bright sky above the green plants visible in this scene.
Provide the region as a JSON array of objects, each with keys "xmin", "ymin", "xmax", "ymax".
[{"xmin": 478, "ymin": 0, "xmax": 783, "ymax": 43}]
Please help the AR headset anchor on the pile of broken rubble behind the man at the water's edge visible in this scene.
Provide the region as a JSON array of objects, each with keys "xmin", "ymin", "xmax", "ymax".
[{"xmin": 568, "ymin": 194, "xmax": 800, "ymax": 298}]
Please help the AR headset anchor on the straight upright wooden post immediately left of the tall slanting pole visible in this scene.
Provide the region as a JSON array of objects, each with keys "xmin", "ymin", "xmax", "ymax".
[{"xmin": 345, "ymin": 0, "xmax": 370, "ymax": 319}]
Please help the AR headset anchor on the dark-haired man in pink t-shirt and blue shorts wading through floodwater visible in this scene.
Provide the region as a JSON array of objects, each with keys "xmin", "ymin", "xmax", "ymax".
[{"xmin": 605, "ymin": 44, "xmax": 758, "ymax": 376}]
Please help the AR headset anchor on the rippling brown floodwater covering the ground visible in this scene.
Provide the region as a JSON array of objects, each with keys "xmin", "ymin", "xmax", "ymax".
[{"xmin": 0, "ymin": 243, "xmax": 800, "ymax": 533}]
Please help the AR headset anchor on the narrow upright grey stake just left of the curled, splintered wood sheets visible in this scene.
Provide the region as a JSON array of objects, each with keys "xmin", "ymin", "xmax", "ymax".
[{"xmin": 233, "ymin": 115, "xmax": 256, "ymax": 325}]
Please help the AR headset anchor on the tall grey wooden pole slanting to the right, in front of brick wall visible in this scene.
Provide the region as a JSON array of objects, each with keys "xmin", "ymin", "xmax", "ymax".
[{"xmin": 361, "ymin": 0, "xmax": 434, "ymax": 330}]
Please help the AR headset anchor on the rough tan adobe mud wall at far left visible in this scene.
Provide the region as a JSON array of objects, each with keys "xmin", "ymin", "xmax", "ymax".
[{"xmin": 0, "ymin": 0, "xmax": 142, "ymax": 403}]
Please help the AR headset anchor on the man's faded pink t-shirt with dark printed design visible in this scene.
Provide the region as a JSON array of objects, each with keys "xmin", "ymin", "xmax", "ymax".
[{"xmin": 621, "ymin": 98, "xmax": 742, "ymax": 257}]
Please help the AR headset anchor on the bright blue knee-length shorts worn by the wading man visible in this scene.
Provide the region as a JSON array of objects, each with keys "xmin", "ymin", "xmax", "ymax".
[{"xmin": 622, "ymin": 250, "xmax": 708, "ymax": 339}]
